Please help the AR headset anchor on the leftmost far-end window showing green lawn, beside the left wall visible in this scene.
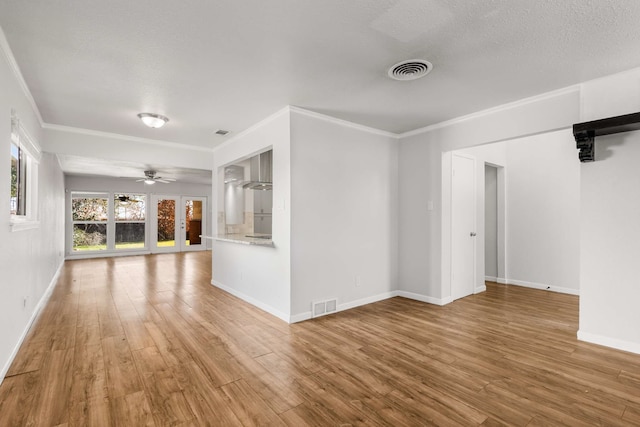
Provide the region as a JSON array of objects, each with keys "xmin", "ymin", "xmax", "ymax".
[{"xmin": 71, "ymin": 193, "xmax": 109, "ymax": 251}]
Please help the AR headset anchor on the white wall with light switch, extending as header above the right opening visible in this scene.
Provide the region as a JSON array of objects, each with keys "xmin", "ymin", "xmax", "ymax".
[{"xmin": 398, "ymin": 88, "xmax": 580, "ymax": 304}]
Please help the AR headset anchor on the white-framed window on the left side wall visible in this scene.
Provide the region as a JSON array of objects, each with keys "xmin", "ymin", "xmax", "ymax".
[{"xmin": 9, "ymin": 113, "xmax": 40, "ymax": 231}]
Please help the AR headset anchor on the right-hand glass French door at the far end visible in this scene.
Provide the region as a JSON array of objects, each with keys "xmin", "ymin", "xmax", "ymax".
[{"xmin": 178, "ymin": 196, "xmax": 207, "ymax": 251}]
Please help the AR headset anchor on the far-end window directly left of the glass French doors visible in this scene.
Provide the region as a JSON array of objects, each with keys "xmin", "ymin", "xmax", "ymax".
[{"xmin": 113, "ymin": 194, "xmax": 146, "ymax": 249}]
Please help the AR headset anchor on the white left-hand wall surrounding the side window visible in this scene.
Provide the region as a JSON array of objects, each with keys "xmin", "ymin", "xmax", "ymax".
[{"xmin": 0, "ymin": 31, "xmax": 64, "ymax": 381}]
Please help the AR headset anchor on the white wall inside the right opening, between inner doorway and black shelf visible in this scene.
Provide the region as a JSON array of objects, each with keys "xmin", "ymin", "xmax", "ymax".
[{"xmin": 506, "ymin": 129, "xmax": 580, "ymax": 295}]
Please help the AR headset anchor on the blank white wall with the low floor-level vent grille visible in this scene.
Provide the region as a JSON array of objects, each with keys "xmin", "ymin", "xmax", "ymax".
[{"xmin": 291, "ymin": 110, "xmax": 398, "ymax": 320}]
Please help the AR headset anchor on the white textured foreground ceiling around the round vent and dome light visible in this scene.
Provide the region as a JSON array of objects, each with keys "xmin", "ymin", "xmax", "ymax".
[{"xmin": 0, "ymin": 0, "xmax": 640, "ymax": 147}]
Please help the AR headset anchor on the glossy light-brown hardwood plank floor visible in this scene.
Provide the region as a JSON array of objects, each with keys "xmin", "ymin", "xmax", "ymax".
[{"xmin": 0, "ymin": 252, "xmax": 640, "ymax": 426}]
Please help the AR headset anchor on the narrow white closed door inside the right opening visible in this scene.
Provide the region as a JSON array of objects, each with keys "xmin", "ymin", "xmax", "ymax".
[{"xmin": 451, "ymin": 154, "xmax": 476, "ymax": 300}]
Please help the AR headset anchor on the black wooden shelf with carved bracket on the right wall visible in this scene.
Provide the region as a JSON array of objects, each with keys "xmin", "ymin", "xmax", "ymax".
[{"xmin": 573, "ymin": 113, "xmax": 640, "ymax": 163}]
